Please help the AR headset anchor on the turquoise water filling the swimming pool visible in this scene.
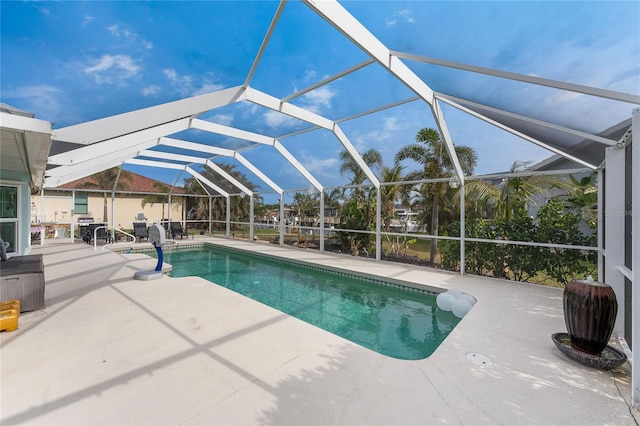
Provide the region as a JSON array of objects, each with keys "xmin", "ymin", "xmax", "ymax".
[{"xmin": 158, "ymin": 247, "xmax": 460, "ymax": 360}]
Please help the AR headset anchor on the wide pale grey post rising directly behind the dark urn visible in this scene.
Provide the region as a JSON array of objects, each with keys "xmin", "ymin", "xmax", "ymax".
[{"xmin": 604, "ymin": 148, "xmax": 625, "ymax": 335}]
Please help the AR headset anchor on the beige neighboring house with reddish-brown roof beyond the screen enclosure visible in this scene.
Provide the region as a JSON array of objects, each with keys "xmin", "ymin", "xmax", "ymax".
[{"xmin": 31, "ymin": 172, "xmax": 186, "ymax": 237}]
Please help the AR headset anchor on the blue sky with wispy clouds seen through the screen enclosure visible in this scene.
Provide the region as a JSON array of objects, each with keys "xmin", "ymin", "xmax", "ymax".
[{"xmin": 0, "ymin": 1, "xmax": 640, "ymax": 200}]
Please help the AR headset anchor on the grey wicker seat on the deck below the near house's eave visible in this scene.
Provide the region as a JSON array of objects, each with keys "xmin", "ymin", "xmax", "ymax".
[{"xmin": 0, "ymin": 254, "xmax": 44, "ymax": 312}]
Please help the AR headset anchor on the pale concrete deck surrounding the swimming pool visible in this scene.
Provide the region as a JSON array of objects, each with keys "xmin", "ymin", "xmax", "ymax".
[{"xmin": 0, "ymin": 236, "xmax": 640, "ymax": 425}]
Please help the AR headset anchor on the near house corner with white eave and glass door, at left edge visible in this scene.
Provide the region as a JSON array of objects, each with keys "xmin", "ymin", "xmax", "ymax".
[{"xmin": 0, "ymin": 103, "xmax": 51, "ymax": 256}]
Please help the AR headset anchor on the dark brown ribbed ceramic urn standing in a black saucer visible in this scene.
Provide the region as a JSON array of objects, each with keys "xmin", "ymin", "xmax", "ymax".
[{"xmin": 563, "ymin": 279, "xmax": 618, "ymax": 355}]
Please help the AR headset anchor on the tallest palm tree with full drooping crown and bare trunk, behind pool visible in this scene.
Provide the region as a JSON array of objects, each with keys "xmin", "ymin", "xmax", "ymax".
[{"xmin": 395, "ymin": 128, "xmax": 478, "ymax": 264}]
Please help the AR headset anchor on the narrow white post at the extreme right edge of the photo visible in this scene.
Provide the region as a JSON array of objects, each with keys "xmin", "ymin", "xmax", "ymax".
[{"xmin": 628, "ymin": 108, "xmax": 640, "ymax": 409}]
